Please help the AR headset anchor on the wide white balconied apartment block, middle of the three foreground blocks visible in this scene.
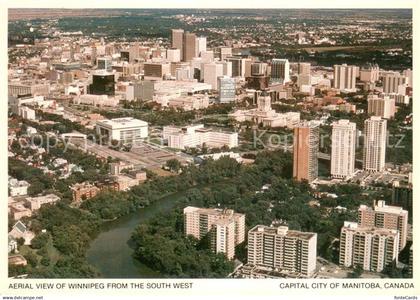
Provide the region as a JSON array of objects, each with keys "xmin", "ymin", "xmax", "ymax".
[{"xmin": 248, "ymin": 225, "xmax": 317, "ymax": 277}]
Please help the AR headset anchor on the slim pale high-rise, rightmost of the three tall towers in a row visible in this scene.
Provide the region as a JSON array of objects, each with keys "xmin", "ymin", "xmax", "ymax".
[{"xmin": 363, "ymin": 116, "xmax": 387, "ymax": 172}]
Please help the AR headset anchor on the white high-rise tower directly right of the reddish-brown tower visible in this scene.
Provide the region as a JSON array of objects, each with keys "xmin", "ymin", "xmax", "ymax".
[{"xmin": 331, "ymin": 120, "xmax": 356, "ymax": 178}]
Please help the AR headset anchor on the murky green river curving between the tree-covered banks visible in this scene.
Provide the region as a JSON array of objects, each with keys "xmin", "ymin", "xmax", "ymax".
[{"xmin": 87, "ymin": 192, "xmax": 184, "ymax": 278}]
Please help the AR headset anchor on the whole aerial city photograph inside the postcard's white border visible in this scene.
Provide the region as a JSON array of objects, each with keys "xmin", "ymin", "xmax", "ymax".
[{"xmin": 4, "ymin": 9, "xmax": 413, "ymax": 288}]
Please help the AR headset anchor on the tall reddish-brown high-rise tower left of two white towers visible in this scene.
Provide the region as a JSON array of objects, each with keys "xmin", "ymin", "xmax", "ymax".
[{"xmin": 293, "ymin": 122, "xmax": 319, "ymax": 182}]
